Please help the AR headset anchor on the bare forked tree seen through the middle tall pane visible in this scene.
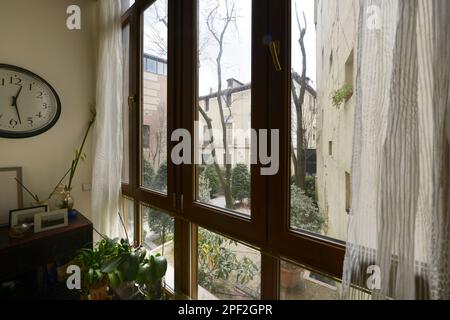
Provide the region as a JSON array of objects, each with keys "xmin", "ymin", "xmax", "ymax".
[{"xmin": 198, "ymin": 0, "xmax": 237, "ymax": 209}]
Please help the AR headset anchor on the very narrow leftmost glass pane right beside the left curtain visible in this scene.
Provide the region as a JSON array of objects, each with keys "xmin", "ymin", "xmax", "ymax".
[{"xmin": 122, "ymin": 25, "xmax": 130, "ymax": 184}]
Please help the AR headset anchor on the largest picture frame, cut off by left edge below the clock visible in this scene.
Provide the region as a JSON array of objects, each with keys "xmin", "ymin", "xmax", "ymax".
[{"xmin": 0, "ymin": 167, "xmax": 23, "ymax": 226}]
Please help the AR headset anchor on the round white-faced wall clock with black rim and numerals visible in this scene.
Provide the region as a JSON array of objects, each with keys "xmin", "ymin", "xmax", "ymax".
[{"xmin": 0, "ymin": 64, "xmax": 61, "ymax": 138}]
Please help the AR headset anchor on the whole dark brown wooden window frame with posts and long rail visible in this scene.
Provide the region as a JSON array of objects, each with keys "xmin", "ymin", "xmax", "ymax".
[{"xmin": 122, "ymin": 0, "xmax": 345, "ymax": 299}]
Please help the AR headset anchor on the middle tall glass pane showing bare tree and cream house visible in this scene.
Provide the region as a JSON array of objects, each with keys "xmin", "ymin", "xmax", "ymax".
[{"xmin": 196, "ymin": 0, "xmax": 252, "ymax": 216}]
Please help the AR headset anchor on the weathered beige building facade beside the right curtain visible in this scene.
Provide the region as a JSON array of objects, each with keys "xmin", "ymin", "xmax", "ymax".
[{"xmin": 316, "ymin": 0, "xmax": 359, "ymax": 240}]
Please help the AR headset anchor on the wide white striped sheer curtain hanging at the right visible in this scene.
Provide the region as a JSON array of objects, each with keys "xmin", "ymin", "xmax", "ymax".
[{"xmin": 342, "ymin": 0, "xmax": 450, "ymax": 299}]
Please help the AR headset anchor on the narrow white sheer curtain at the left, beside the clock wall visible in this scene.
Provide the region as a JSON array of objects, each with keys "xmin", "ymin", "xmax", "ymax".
[{"xmin": 92, "ymin": 0, "xmax": 123, "ymax": 237}]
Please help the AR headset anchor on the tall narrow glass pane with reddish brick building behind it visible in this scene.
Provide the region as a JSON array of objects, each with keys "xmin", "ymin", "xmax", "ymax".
[{"xmin": 141, "ymin": 0, "xmax": 168, "ymax": 193}]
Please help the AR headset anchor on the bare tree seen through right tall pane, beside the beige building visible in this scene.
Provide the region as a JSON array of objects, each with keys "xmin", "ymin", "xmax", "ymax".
[{"xmin": 291, "ymin": 3, "xmax": 308, "ymax": 190}]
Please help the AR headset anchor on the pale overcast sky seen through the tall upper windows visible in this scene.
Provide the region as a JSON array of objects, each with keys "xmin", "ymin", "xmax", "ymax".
[{"xmin": 144, "ymin": 0, "xmax": 316, "ymax": 96}]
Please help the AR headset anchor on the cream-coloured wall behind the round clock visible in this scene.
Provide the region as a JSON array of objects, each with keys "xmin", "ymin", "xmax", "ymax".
[{"xmin": 0, "ymin": 0, "xmax": 96, "ymax": 217}]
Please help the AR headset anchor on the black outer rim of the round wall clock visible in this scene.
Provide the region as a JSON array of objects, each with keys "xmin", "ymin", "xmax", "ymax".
[{"xmin": 0, "ymin": 63, "xmax": 61, "ymax": 139}]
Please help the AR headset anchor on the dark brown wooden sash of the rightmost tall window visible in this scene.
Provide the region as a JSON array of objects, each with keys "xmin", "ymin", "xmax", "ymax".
[{"xmin": 267, "ymin": 0, "xmax": 345, "ymax": 278}]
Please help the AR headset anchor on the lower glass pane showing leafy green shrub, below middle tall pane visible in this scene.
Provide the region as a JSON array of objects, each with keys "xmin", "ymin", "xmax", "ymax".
[{"xmin": 198, "ymin": 228, "xmax": 261, "ymax": 300}]
